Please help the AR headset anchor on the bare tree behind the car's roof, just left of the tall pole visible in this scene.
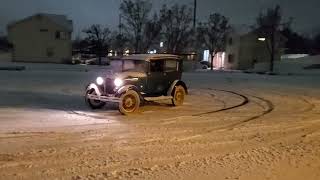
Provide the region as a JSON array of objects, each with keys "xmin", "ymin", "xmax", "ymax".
[{"xmin": 160, "ymin": 4, "xmax": 193, "ymax": 54}]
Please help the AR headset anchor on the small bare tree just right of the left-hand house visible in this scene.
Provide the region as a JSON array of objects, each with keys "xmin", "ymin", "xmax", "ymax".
[{"xmin": 83, "ymin": 24, "xmax": 111, "ymax": 65}]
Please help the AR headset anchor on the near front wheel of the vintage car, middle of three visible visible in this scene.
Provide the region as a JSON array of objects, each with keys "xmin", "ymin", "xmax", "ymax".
[{"xmin": 119, "ymin": 90, "xmax": 140, "ymax": 115}]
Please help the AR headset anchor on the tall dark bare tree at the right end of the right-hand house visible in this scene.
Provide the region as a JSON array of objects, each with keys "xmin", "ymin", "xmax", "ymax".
[{"xmin": 256, "ymin": 5, "xmax": 290, "ymax": 72}]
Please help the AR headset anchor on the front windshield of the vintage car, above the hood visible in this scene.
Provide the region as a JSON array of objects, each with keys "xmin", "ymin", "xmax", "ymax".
[{"xmin": 110, "ymin": 59, "xmax": 146, "ymax": 72}]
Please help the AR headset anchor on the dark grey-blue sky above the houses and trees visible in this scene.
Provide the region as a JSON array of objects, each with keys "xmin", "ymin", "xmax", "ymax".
[{"xmin": 0, "ymin": 0, "xmax": 320, "ymax": 35}]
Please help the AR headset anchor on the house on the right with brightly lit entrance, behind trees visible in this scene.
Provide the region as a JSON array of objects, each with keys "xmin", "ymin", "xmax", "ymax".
[{"xmin": 203, "ymin": 27, "xmax": 285, "ymax": 70}]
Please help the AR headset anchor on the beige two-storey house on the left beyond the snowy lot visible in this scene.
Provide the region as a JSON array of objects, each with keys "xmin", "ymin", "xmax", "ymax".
[{"xmin": 7, "ymin": 14, "xmax": 73, "ymax": 63}]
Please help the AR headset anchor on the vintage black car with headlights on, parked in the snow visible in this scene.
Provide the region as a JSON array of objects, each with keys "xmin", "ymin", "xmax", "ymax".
[{"xmin": 85, "ymin": 54, "xmax": 188, "ymax": 115}]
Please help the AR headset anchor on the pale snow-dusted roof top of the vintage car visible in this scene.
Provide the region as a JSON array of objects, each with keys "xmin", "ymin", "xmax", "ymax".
[{"xmin": 122, "ymin": 54, "xmax": 179, "ymax": 61}]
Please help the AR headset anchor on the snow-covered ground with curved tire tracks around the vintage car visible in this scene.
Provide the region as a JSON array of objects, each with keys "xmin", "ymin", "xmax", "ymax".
[{"xmin": 0, "ymin": 66, "xmax": 320, "ymax": 180}]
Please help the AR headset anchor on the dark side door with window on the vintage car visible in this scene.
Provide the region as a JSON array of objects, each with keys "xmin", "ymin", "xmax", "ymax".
[{"xmin": 147, "ymin": 59, "xmax": 167, "ymax": 96}]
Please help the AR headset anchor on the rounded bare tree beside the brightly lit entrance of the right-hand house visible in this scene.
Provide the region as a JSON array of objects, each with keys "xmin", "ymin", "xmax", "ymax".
[{"xmin": 197, "ymin": 13, "xmax": 231, "ymax": 70}]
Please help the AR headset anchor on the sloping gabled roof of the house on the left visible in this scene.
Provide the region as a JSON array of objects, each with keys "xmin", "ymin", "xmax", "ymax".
[{"xmin": 8, "ymin": 13, "xmax": 73, "ymax": 32}]
